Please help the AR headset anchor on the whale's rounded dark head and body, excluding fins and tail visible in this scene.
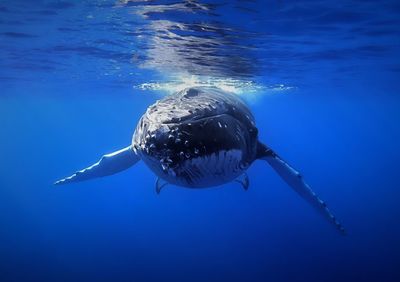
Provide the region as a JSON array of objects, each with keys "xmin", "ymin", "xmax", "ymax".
[{"xmin": 132, "ymin": 87, "xmax": 257, "ymax": 187}]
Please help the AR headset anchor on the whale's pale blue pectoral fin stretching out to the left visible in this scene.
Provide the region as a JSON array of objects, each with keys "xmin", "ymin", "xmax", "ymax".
[{"xmin": 54, "ymin": 146, "xmax": 140, "ymax": 185}]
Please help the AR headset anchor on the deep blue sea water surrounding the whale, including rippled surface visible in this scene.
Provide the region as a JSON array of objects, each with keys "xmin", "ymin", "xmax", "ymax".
[{"xmin": 0, "ymin": 0, "xmax": 400, "ymax": 282}]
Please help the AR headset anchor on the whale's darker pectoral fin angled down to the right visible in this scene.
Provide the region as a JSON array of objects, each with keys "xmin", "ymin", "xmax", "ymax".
[{"xmin": 258, "ymin": 143, "xmax": 346, "ymax": 234}]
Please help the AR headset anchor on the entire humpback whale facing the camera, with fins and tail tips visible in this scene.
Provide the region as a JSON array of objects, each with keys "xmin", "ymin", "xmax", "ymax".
[{"xmin": 55, "ymin": 87, "xmax": 344, "ymax": 232}]
